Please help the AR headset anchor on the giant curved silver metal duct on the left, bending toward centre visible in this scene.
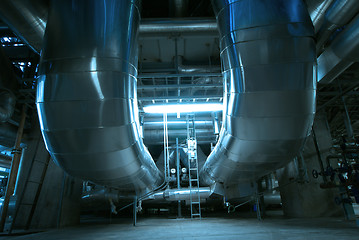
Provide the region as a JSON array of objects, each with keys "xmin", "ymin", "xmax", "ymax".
[{"xmin": 37, "ymin": 0, "xmax": 162, "ymax": 192}]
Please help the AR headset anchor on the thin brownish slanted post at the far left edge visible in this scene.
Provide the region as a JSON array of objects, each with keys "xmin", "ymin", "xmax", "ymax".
[{"xmin": 0, "ymin": 105, "xmax": 27, "ymax": 232}]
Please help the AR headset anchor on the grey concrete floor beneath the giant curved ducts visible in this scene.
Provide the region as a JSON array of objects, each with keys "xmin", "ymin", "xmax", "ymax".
[{"xmin": 1, "ymin": 217, "xmax": 359, "ymax": 240}]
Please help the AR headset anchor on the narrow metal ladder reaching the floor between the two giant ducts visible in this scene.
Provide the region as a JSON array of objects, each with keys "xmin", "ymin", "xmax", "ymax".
[{"xmin": 187, "ymin": 114, "xmax": 201, "ymax": 219}]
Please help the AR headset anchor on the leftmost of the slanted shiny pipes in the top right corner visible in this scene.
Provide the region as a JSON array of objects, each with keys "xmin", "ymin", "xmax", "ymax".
[{"xmin": 306, "ymin": 0, "xmax": 334, "ymax": 32}]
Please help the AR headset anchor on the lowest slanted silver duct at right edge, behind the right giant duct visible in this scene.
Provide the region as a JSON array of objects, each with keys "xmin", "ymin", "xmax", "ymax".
[{"xmin": 318, "ymin": 15, "xmax": 359, "ymax": 83}]
